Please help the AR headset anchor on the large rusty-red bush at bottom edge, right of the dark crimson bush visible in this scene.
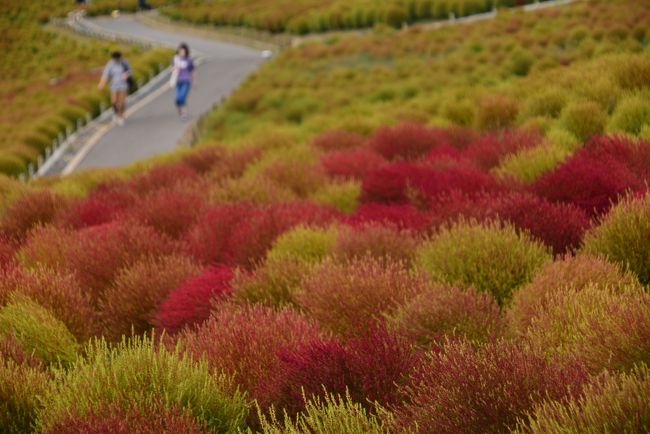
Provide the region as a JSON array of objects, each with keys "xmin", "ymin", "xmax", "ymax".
[{"xmin": 396, "ymin": 342, "xmax": 588, "ymax": 433}]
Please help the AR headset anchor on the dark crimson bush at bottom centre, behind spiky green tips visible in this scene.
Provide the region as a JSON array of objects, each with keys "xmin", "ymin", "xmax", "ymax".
[{"xmin": 261, "ymin": 328, "xmax": 421, "ymax": 415}]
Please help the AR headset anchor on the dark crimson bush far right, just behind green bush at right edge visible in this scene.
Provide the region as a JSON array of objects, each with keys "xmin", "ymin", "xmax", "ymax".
[{"xmin": 531, "ymin": 154, "xmax": 645, "ymax": 216}]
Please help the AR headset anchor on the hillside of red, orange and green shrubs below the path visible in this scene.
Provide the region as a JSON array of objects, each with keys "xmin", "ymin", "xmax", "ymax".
[{"xmin": 0, "ymin": 0, "xmax": 650, "ymax": 434}]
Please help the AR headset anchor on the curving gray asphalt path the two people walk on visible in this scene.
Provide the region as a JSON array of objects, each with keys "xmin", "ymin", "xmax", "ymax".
[{"xmin": 75, "ymin": 16, "xmax": 263, "ymax": 171}]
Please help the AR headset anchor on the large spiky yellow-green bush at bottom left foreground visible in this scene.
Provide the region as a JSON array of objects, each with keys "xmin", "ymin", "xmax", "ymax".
[{"xmin": 38, "ymin": 336, "xmax": 248, "ymax": 433}]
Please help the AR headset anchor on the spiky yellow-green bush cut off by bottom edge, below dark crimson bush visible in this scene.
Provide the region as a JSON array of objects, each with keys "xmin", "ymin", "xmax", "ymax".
[{"xmin": 260, "ymin": 395, "xmax": 392, "ymax": 434}]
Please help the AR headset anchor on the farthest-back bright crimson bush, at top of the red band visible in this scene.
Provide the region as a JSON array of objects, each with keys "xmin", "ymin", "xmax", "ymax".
[{"xmin": 370, "ymin": 122, "xmax": 447, "ymax": 160}]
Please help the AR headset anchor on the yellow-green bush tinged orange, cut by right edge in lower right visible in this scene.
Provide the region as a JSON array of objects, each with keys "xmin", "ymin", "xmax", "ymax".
[{"xmin": 525, "ymin": 283, "xmax": 650, "ymax": 372}]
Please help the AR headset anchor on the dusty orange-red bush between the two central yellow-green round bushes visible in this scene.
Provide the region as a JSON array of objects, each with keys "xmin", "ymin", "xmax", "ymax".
[{"xmin": 332, "ymin": 223, "xmax": 418, "ymax": 265}]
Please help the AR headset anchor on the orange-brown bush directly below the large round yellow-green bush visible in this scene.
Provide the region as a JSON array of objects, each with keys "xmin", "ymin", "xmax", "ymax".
[{"xmin": 389, "ymin": 285, "xmax": 503, "ymax": 347}]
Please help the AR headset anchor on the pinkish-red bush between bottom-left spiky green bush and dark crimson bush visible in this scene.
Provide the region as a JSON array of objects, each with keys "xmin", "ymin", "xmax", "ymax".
[{"xmin": 179, "ymin": 304, "xmax": 320, "ymax": 399}]
